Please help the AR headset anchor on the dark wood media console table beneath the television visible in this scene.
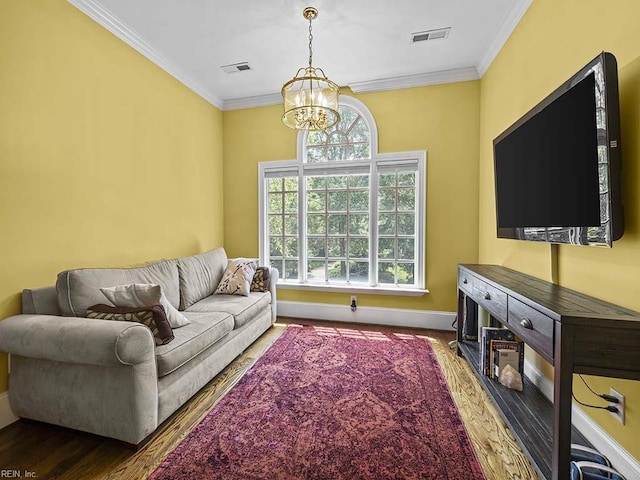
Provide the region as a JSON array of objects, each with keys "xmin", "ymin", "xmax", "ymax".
[{"xmin": 458, "ymin": 265, "xmax": 640, "ymax": 480}]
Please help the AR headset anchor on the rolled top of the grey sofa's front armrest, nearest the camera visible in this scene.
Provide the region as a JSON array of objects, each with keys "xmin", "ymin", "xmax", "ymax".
[{"xmin": 0, "ymin": 314, "xmax": 155, "ymax": 366}]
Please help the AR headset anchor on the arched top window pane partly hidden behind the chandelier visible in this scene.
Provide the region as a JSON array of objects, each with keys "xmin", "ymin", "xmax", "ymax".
[{"xmin": 303, "ymin": 104, "xmax": 375, "ymax": 163}]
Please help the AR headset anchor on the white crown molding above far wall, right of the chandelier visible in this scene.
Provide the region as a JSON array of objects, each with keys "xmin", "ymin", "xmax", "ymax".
[{"xmin": 349, "ymin": 67, "xmax": 480, "ymax": 93}]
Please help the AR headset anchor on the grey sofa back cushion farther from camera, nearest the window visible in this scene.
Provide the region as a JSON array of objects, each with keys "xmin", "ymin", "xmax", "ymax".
[{"xmin": 177, "ymin": 247, "xmax": 227, "ymax": 310}]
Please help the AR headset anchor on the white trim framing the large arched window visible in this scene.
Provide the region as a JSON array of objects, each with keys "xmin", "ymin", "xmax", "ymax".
[{"xmin": 258, "ymin": 96, "xmax": 429, "ymax": 296}]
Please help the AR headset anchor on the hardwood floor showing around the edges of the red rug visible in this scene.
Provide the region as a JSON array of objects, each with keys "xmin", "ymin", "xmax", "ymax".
[{"xmin": 0, "ymin": 318, "xmax": 537, "ymax": 480}]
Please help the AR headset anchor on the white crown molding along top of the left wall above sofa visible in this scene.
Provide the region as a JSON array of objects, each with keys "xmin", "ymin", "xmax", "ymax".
[{"xmin": 67, "ymin": 0, "xmax": 223, "ymax": 109}]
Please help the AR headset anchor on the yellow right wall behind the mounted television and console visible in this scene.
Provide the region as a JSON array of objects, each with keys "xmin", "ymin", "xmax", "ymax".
[{"xmin": 479, "ymin": 0, "xmax": 640, "ymax": 458}]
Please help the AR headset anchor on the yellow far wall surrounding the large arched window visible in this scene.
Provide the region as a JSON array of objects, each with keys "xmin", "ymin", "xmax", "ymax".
[{"xmin": 223, "ymin": 81, "xmax": 480, "ymax": 311}]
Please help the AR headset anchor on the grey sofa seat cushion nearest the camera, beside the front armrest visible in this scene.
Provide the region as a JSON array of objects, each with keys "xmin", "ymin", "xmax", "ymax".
[{"xmin": 156, "ymin": 312, "xmax": 233, "ymax": 377}]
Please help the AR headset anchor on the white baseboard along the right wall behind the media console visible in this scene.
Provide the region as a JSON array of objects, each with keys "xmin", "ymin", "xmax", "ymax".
[{"xmin": 524, "ymin": 360, "xmax": 640, "ymax": 480}]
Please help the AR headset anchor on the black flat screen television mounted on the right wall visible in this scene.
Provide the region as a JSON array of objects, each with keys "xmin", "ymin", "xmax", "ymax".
[{"xmin": 493, "ymin": 52, "xmax": 624, "ymax": 247}]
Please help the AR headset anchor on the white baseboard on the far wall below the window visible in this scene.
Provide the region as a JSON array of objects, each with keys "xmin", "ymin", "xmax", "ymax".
[{"xmin": 278, "ymin": 300, "xmax": 456, "ymax": 330}]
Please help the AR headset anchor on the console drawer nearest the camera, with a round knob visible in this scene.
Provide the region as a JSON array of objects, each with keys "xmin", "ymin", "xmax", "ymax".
[{"xmin": 509, "ymin": 297, "xmax": 555, "ymax": 363}]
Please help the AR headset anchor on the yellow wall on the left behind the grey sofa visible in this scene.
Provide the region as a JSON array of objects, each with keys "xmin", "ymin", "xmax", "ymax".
[{"xmin": 0, "ymin": 0, "xmax": 223, "ymax": 392}]
